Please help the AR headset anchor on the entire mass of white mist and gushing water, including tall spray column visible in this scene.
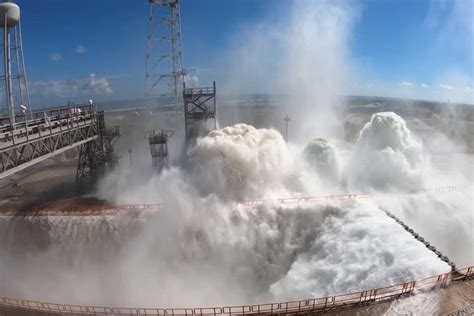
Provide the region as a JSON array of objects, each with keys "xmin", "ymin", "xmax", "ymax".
[{"xmin": 0, "ymin": 1, "xmax": 474, "ymax": 308}]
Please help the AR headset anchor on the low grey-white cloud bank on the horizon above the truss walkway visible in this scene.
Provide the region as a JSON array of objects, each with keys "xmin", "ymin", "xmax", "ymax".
[{"xmin": 30, "ymin": 74, "xmax": 113, "ymax": 98}]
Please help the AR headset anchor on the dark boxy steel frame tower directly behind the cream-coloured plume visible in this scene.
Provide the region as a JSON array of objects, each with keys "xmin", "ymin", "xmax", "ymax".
[{"xmin": 183, "ymin": 81, "xmax": 217, "ymax": 145}]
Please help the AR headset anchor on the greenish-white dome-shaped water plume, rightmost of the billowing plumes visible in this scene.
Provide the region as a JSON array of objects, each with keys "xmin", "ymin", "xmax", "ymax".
[{"xmin": 347, "ymin": 112, "xmax": 429, "ymax": 191}]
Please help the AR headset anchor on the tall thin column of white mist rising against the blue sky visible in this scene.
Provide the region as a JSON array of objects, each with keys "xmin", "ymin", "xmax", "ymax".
[{"xmin": 222, "ymin": 0, "xmax": 359, "ymax": 142}]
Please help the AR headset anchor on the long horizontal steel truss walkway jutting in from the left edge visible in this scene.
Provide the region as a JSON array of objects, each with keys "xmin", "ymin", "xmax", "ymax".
[{"xmin": 0, "ymin": 103, "xmax": 99, "ymax": 179}]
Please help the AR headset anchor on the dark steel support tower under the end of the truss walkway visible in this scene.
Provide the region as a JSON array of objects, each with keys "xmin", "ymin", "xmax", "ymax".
[{"xmin": 76, "ymin": 111, "xmax": 120, "ymax": 182}]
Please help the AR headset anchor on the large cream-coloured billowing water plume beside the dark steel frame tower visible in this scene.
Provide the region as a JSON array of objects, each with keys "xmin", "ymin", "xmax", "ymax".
[{"xmin": 190, "ymin": 124, "xmax": 292, "ymax": 199}]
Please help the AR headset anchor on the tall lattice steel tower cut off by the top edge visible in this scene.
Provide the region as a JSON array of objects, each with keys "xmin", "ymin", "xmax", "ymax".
[{"xmin": 145, "ymin": 0, "xmax": 186, "ymax": 109}]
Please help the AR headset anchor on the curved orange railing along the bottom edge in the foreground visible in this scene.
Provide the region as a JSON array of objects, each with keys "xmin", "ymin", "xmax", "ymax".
[{"xmin": 0, "ymin": 266, "xmax": 474, "ymax": 316}]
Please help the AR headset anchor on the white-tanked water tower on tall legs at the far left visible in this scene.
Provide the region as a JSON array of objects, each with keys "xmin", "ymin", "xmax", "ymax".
[{"xmin": 0, "ymin": 0, "xmax": 30, "ymax": 129}]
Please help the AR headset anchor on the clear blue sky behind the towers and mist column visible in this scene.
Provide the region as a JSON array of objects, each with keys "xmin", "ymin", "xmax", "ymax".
[{"xmin": 16, "ymin": 0, "xmax": 474, "ymax": 104}]
